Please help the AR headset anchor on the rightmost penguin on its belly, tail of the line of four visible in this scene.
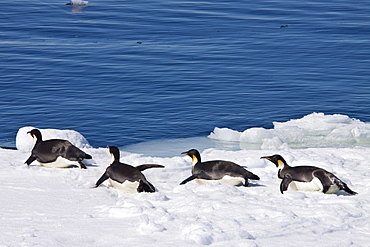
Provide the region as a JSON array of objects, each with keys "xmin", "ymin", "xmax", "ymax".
[{"xmin": 261, "ymin": 155, "xmax": 357, "ymax": 195}]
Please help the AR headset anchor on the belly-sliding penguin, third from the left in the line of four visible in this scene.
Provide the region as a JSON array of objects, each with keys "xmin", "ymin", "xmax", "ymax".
[{"xmin": 180, "ymin": 149, "xmax": 260, "ymax": 186}]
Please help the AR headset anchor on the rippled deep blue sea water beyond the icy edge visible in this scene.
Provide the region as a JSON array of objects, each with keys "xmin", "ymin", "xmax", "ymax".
[{"xmin": 0, "ymin": 0, "xmax": 370, "ymax": 151}]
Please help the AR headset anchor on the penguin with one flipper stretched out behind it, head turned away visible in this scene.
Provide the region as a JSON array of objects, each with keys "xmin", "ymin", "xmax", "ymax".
[{"xmin": 95, "ymin": 146, "xmax": 164, "ymax": 193}]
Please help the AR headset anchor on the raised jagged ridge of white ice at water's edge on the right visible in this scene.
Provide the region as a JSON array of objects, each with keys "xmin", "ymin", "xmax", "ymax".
[{"xmin": 208, "ymin": 113, "xmax": 370, "ymax": 150}]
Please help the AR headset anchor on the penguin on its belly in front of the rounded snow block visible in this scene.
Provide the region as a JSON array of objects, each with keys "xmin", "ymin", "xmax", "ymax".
[{"xmin": 25, "ymin": 129, "xmax": 92, "ymax": 169}]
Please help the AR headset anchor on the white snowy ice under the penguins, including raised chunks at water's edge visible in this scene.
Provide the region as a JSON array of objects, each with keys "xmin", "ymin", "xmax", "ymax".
[{"xmin": 0, "ymin": 114, "xmax": 370, "ymax": 247}]
